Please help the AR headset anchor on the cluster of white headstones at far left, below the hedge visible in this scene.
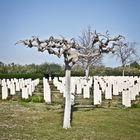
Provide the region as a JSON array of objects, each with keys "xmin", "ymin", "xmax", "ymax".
[{"xmin": 1, "ymin": 78, "xmax": 39, "ymax": 99}]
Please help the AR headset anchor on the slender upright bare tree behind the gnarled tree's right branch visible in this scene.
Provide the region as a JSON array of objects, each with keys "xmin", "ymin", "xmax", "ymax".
[{"xmin": 79, "ymin": 26, "xmax": 103, "ymax": 79}]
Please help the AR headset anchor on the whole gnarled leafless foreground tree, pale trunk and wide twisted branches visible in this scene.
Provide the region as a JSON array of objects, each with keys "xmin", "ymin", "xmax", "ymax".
[{"xmin": 16, "ymin": 32, "xmax": 122, "ymax": 129}]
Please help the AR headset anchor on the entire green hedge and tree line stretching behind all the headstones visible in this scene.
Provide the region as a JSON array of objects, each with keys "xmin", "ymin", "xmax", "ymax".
[{"xmin": 0, "ymin": 61, "xmax": 140, "ymax": 79}]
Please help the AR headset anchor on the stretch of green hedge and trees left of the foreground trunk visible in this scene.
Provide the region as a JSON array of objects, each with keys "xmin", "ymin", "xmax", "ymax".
[{"xmin": 0, "ymin": 62, "xmax": 64, "ymax": 79}]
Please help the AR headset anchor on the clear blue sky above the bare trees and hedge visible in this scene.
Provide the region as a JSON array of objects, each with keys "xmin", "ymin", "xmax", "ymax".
[{"xmin": 0, "ymin": 0, "xmax": 140, "ymax": 67}]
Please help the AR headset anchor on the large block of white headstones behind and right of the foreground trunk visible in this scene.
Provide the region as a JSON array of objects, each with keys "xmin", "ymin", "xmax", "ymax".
[{"xmin": 53, "ymin": 76, "xmax": 140, "ymax": 107}]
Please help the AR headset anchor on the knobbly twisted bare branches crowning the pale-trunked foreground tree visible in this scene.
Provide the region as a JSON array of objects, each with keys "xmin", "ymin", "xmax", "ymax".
[{"xmin": 15, "ymin": 30, "xmax": 123, "ymax": 66}]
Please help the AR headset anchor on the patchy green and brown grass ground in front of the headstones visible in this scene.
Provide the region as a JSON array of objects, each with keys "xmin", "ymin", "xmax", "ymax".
[{"xmin": 0, "ymin": 80, "xmax": 140, "ymax": 140}]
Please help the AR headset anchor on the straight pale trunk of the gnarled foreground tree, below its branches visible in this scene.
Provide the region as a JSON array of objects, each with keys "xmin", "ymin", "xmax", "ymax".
[{"xmin": 63, "ymin": 65, "xmax": 71, "ymax": 129}]
